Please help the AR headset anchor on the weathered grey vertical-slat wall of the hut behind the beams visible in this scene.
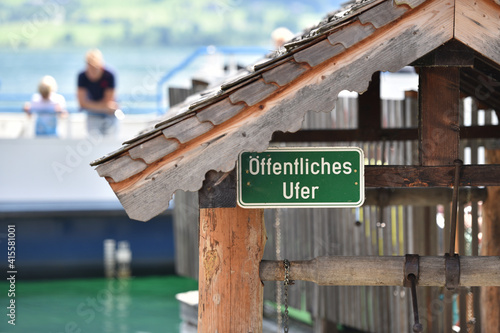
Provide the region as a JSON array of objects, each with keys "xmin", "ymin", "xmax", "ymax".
[{"xmin": 175, "ymin": 94, "xmax": 496, "ymax": 333}]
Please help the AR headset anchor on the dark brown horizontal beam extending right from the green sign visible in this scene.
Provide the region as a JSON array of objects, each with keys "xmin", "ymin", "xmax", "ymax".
[{"xmin": 365, "ymin": 164, "xmax": 500, "ymax": 187}]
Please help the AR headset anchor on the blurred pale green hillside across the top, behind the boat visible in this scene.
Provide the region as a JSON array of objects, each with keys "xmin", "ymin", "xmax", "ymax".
[{"xmin": 0, "ymin": 0, "xmax": 338, "ymax": 49}]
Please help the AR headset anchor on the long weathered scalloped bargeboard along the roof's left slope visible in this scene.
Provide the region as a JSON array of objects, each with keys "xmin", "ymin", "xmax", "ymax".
[{"xmin": 105, "ymin": 0, "xmax": 453, "ymax": 220}]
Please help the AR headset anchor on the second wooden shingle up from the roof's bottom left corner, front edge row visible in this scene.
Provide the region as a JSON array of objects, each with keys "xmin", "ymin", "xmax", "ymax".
[{"xmin": 129, "ymin": 135, "xmax": 179, "ymax": 164}]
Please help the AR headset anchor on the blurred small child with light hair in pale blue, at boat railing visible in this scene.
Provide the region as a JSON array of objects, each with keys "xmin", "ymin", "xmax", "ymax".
[{"xmin": 23, "ymin": 75, "xmax": 68, "ymax": 136}]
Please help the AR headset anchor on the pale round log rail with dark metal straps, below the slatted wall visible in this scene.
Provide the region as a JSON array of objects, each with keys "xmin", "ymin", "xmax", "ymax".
[{"xmin": 260, "ymin": 256, "xmax": 500, "ymax": 287}]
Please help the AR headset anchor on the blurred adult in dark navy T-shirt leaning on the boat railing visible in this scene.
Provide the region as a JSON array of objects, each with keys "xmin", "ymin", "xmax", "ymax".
[{"xmin": 77, "ymin": 49, "xmax": 118, "ymax": 135}]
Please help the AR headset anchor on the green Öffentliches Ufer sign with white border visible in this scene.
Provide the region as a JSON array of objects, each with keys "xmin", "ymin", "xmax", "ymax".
[{"xmin": 238, "ymin": 147, "xmax": 365, "ymax": 208}]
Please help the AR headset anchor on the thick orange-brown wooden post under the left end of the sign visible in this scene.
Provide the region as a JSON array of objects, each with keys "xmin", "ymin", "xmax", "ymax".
[{"xmin": 198, "ymin": 171, "xmax": 266, "ymax": 333}]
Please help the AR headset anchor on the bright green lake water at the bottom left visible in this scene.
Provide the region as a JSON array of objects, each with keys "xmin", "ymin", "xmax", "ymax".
[{"xmin": 0, "ymin": 276, "xmax": 198, "ymax": 333}]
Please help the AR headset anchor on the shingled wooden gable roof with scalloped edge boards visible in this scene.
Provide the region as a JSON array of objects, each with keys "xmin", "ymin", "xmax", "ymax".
[{"xmin": 92, "ymin": 0, "xmax": 500, "ymax": 221}]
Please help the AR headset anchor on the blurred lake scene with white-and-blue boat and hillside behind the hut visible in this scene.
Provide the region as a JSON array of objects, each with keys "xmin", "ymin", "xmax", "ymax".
[{"xmin": 0, "ymin": 0, "xmax": 348, "ymax": 333}]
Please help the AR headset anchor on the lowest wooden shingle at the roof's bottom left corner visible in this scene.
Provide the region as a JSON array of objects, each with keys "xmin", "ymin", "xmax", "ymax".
[{"xmin": 96, "ymin": 155, "xmax": 148, "ymax": 183}]
